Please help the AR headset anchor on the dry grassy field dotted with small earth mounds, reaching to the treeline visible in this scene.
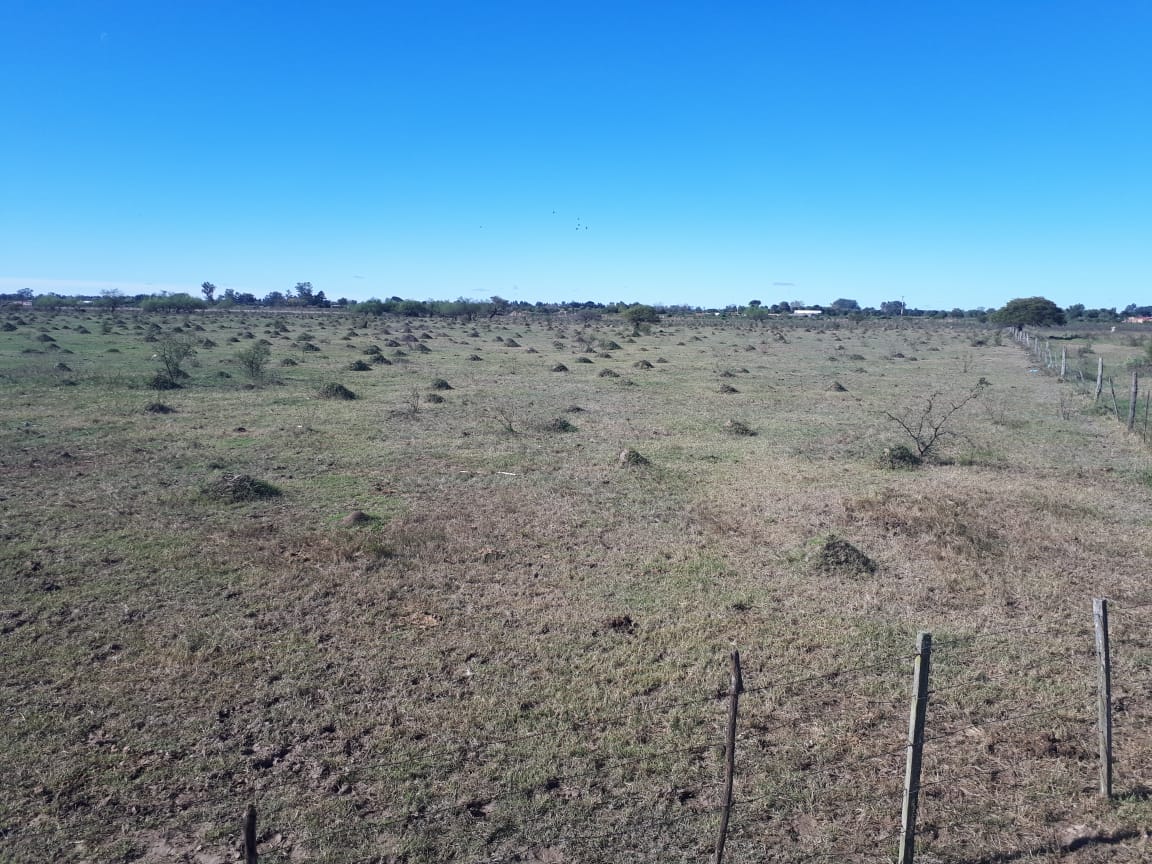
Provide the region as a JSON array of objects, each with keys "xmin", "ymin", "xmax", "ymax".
[{"xmin": 0, "ymin": 309, "xmax": 1152, "ymax": 864}]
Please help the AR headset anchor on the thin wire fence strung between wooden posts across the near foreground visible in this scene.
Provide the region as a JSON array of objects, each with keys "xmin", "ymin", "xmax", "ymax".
[{"xmin": 11, "ymin": 600, "xmax": 1152, "ymax": 864}]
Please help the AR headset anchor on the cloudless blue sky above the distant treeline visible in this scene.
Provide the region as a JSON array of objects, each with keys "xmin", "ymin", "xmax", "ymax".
[{"xmin": 0, "ymin": 0, "xmax": 1152, "ymax": 309}]
